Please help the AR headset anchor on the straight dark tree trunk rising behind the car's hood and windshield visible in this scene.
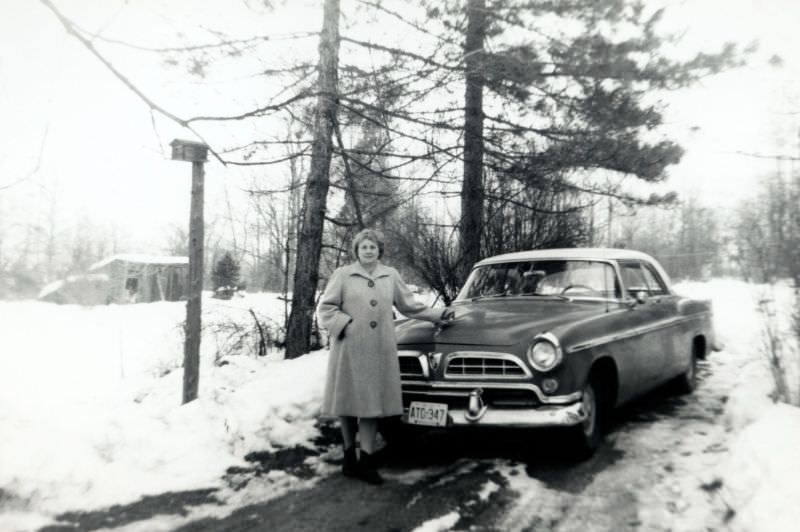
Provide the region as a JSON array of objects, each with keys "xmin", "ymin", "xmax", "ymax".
[{"xmin": 460, "ymin": 0, "xmax": 486, "ymax": 279}]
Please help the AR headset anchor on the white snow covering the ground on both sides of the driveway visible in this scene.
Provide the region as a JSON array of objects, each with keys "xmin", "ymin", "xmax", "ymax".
[{"xmin": 0, "ymin": 280, "xmax": 800, "ymax": 531}]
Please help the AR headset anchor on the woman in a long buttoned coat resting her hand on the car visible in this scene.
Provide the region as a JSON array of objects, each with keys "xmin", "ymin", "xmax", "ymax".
[{"xmin": 317, "ymin": 229, "xmax": 455, "ymax": 484}]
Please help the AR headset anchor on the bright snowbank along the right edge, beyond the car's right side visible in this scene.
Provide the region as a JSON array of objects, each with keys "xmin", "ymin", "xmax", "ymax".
[{"xmin": 678, "ymin": 280, "xmax": 800, "ymax": 532}]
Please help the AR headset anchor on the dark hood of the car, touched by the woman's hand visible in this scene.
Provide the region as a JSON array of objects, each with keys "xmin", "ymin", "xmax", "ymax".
[{"xmin": 397, "ymin": 298, "xmax": 603, "ymax": 346}]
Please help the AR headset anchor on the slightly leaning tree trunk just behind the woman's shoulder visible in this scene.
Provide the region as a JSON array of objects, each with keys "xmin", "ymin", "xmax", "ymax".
[{"xmin": 286, "ymin": 0, "xmax": 339, "ymax": 358}]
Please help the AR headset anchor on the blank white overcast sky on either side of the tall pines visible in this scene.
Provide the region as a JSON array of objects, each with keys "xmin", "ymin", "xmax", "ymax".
[{"xmin": 0, "ymin": 0, "xmax": 800, "ymax": 251}]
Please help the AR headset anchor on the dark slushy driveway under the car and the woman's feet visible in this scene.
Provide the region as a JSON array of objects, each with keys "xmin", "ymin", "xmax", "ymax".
[{"xmin": 43, "ymin": 354, "xmax": 733, "ymax": 532}]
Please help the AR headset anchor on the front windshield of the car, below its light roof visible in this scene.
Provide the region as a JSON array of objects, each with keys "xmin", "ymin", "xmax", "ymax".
[{"xmin": 456, "ymin": 260, "xmax": 621, "ymax": 301}]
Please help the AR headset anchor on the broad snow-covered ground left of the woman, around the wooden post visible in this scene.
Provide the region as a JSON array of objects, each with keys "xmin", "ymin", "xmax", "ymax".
[{"xmin": 0, "ymin": 294, "xmax": 327, "ymax": 530}]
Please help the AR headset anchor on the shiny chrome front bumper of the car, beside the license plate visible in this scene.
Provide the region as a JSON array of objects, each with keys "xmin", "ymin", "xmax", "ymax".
[{"xmin": 403, "ymin": 402, "xmax": 586, "ymax": 428}]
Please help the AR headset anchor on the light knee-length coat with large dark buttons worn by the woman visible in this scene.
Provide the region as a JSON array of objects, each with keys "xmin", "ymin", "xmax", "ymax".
[{"xmin": 317, "ymin": 262, "xmax": 442, "ymax": 417}]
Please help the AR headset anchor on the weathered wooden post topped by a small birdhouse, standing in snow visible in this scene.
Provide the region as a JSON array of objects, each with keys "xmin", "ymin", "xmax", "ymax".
[{"xmin": 170, "ymin": 139, "xmax": 208, "ymax": 404}]
